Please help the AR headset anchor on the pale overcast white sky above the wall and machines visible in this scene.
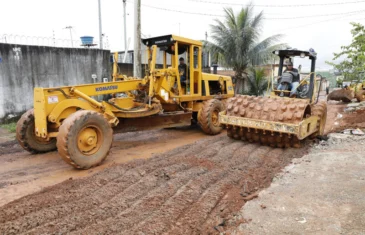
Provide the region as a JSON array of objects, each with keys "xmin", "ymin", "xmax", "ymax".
[{"xmin": 0, "ymin": 0, "xmax": 365, "ymax": 70}]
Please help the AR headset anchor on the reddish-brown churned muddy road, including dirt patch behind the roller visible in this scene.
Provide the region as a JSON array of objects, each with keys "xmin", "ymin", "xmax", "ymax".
[{"xmin": 0, "ymin": 101, "xmax": 365, "ymax": 234}]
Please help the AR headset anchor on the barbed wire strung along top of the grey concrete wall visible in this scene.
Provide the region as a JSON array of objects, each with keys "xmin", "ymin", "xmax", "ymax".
[{"xmin": 0, "ymin": 34, "xmax": 109, "ymax": 49}]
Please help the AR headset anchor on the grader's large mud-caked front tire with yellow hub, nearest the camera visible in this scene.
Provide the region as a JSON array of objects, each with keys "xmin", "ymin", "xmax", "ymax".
[{"xmin": 57, "ymin": 110, "xmax": 113, "ymax": 169}]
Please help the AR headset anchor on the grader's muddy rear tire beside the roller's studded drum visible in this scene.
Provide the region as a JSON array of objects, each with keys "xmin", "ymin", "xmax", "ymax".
[{"xmin": 198, "ymin": 99, "xmax": 225, "ymax": 135}]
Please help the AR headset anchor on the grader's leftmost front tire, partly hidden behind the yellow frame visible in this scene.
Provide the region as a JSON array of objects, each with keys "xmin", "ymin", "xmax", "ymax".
[{"xmin": 16, "ymin": 109, "xmax": 57, "ymax": 153}]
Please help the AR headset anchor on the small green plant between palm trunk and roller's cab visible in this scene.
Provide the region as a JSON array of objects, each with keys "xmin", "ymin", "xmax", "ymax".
[{"xmin": 248, "ymin": 68, "xmax": 268, "ymax": 96}]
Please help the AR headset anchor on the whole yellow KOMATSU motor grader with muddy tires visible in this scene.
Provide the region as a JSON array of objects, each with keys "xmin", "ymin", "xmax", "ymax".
[{"xmin": 16, "ymin": 35, "xmax": 234, "ymax": 169}]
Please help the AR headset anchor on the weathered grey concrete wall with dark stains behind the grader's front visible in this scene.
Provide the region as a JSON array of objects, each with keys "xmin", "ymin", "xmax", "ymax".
[{"xmin": 0, "ymin": 43, "xmax": 111, "ymax": 122}]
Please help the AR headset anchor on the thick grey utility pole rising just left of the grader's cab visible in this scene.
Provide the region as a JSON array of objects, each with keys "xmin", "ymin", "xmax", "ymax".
[{"xmin": 133, "ymin": 0, "xmax": 142, "ymax": 78}]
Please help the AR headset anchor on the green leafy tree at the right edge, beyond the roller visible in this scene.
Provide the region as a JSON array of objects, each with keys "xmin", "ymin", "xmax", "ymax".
[{"xmin": 327, "ymin": 23, "xmax": 365, "ymax": 80}]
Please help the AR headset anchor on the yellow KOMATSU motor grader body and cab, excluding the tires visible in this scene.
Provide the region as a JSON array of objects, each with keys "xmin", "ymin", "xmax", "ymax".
[{"xmin": 34, "ymin": 35, "xmax": 234, "ymax": 139}]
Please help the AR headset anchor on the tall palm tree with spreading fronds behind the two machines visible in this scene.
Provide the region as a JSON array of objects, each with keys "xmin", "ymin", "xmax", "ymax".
[{"xmin": 205, "ymin": 6, "xmax": 285, "ymax": 94}]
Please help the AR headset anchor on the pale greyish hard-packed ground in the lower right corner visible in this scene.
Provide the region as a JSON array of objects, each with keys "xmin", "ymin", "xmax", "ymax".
[{"xmin": 233, "ymin": 133, "xmax": 365, "ymax": 235}]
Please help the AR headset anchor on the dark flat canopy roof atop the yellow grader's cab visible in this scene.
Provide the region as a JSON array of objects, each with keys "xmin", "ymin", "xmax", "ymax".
[{"xmin": 142, "ymin": 34, "xmax": 202, "ymax": 47}]
